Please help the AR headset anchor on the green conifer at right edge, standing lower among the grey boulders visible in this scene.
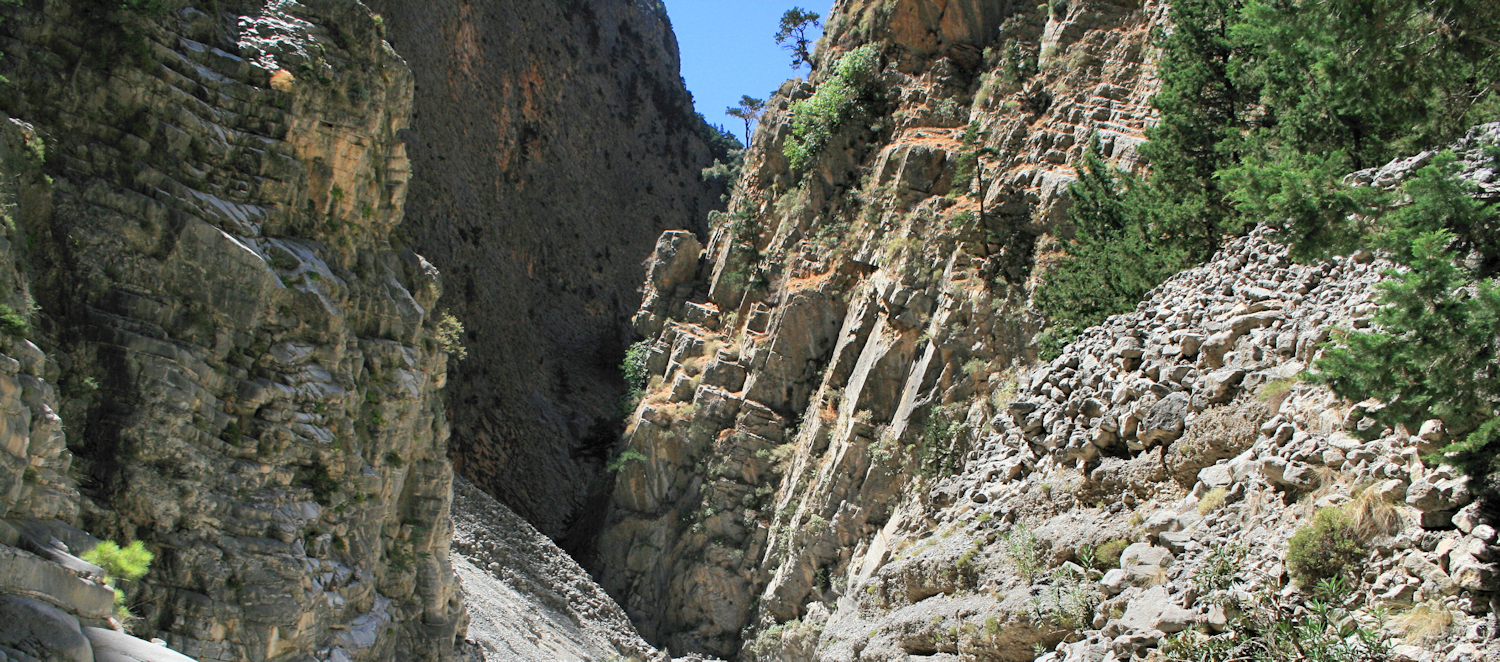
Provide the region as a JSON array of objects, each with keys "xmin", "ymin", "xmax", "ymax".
[{"xmin": 1314, "ymin": 155, "xmax": 1500, "ymax": 477}]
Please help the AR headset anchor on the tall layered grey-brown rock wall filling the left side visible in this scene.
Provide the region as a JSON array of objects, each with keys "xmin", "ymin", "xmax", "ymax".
[{"xmin": 0, "ymin": 0, "xmax": 467, "ymax": 660}]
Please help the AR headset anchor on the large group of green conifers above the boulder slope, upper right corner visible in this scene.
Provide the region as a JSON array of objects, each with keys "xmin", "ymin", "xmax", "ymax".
[{"xmin": 1038, "ymin": 0, "xmax": 1500, "ymax": 345}]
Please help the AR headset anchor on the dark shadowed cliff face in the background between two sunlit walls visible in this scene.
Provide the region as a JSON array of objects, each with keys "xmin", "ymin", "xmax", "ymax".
[{"xmin": 369, "ymin": 0, "xmax": 717, "ymax": 551}]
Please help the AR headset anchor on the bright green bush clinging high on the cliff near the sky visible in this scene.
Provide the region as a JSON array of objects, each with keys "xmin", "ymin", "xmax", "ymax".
[{"xmin": 783, "ymin": 44, "xmax": 881, "ymax": 170}]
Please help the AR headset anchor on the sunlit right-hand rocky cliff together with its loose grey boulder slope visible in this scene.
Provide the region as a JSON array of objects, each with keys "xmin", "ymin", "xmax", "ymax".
[{"xmin": 594, "ymin": 0, "xmax": 1500, "ymax": 662}]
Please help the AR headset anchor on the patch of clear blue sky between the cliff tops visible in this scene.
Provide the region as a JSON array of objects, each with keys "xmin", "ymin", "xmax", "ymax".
[{"xmin": 663, "ymin": 0, "xmax": 833, "ymax": 140}]
